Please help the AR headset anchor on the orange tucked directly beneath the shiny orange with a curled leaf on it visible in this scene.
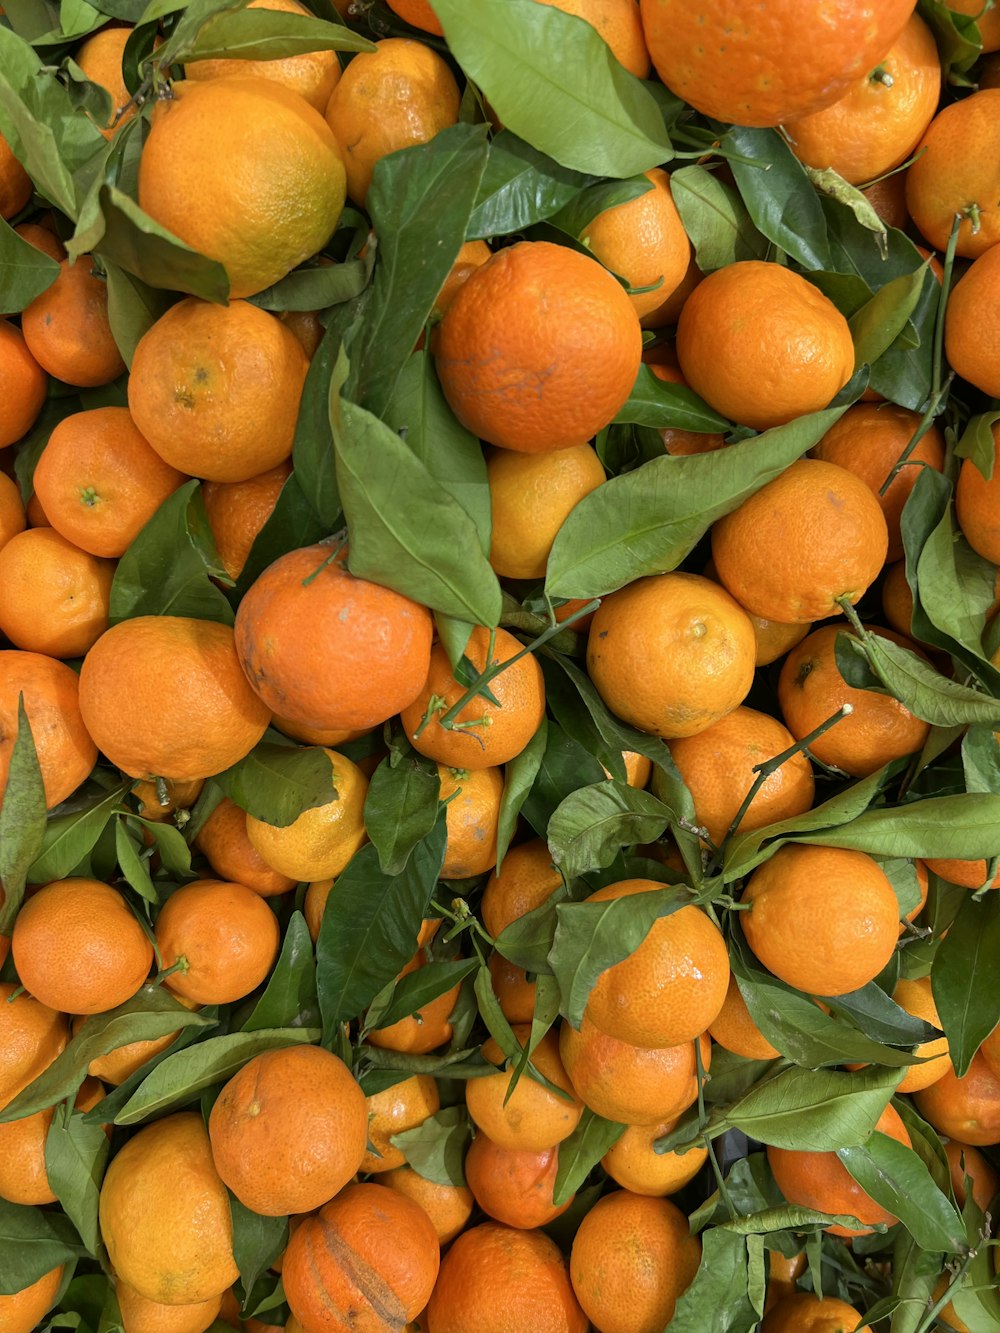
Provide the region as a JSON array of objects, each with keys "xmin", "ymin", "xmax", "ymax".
[{"xmin": 559, "ymin": 1016, "xmax": 712, "ymax": 1125}]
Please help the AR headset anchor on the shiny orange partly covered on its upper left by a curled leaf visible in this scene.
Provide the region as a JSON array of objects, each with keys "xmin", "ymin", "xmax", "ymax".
[{"xmin": 584, "ymin": 880, "xmax": 729, "ymax": 1046}]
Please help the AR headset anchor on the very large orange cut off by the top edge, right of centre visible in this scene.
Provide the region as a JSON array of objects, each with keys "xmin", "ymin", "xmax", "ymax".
[{"xmin": 640, "ymin": 0, "xmax": 916, "ymax": 125}]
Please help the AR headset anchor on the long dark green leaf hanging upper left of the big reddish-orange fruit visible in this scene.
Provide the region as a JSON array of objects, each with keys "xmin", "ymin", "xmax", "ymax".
[{"xmin": 344, "ymin": 124, "xmax": 487, "ymax": 417}]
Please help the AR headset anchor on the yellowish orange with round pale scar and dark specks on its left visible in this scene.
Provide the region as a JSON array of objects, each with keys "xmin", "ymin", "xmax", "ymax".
[{"xmin": 587, "ymin": 573, "xmax": 755, "ymax": 740}]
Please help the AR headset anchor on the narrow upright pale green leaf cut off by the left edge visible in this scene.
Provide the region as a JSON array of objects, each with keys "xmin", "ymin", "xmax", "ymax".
[{"xmin": 0, "ymin": 692, "xmax": 47, "ymax": 934}]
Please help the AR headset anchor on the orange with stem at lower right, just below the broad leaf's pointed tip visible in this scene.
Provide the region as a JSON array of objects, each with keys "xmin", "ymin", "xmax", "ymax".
[{"xmin": 712, "ymin": 459, "xmax": 888, "ymax": 624}]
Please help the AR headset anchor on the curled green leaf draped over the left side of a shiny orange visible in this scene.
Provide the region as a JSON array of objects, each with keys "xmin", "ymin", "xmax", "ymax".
[{"xmin": 549, "ymin": 888, "xmax": 691, "ymax": 1028}]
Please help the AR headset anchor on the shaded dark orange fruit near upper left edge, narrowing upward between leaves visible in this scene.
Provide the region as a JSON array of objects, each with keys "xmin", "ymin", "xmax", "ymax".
[{"xmin": 21, "ymin": 255, "xmax": 125, "ymax": 389}]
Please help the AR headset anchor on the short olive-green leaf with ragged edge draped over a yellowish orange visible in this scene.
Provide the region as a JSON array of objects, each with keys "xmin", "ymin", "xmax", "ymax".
[{"xmin": 215, "ymin": 740, "xmax": 337, "ymax": 828}]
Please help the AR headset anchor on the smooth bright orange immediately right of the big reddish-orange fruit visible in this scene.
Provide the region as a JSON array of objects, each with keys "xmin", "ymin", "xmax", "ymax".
[{"xmin": 677, "ymin": 260, "xmax": 855, "ymax": 431}]
